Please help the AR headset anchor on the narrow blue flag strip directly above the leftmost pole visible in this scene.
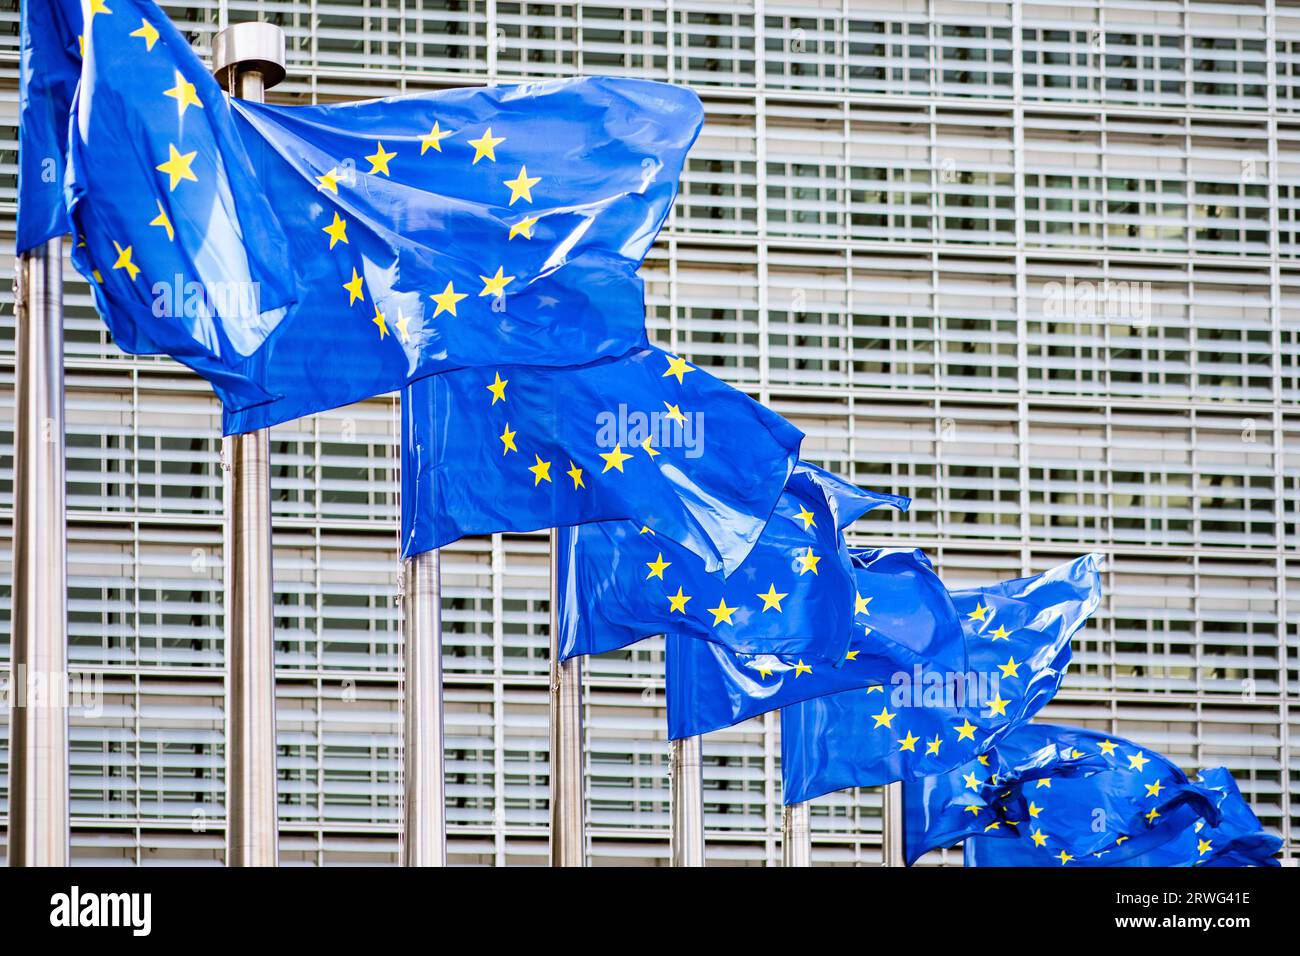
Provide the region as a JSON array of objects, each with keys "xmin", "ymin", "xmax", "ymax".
[{"xmin": 17, "ymin": 0, "xmax": 82, "ymax": 252}]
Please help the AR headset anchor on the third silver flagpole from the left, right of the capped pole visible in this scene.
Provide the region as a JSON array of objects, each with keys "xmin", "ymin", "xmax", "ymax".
[{"xmin": 402, "ymin": 551, "xmax": 447, "ymax": 866}]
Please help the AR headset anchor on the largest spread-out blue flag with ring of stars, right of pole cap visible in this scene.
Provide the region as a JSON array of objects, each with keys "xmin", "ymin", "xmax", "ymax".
[{"xmin": 225, "ymin": 77, "xmax": 703, "ymax": 437}]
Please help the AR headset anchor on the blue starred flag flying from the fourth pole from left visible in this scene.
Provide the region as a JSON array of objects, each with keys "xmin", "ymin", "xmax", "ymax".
[{"xmin": 559, "ymin": 463, "xmax": 909, "ymax": 662}]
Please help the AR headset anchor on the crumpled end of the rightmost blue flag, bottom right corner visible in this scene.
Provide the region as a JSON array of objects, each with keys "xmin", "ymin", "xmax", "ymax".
[{"xmin": 1119, "ymin": 767, "xmax": 1282, "ymax": 866}]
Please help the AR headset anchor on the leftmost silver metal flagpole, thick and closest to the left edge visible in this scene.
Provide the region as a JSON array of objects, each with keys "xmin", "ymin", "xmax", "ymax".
[{"xmin": 9, "ymin": 238, "xmax": 69, "ymax": 866}]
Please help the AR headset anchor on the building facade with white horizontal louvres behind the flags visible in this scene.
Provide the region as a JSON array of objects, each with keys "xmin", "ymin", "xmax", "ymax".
[{"xmin": 0, "ymin": 0, "xmax": 1300, "ymax": 865}]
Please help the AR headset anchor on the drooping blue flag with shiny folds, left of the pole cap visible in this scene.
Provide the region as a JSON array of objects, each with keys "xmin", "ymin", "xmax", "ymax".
[{"xmin": 65, "ymin": 0, "xmax": 296, "ymax": 402}]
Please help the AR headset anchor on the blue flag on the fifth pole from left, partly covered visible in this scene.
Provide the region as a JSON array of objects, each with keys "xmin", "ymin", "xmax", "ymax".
[{"xmin": 670, "ymin": 549, "xmax": 966, "ymax": 739}]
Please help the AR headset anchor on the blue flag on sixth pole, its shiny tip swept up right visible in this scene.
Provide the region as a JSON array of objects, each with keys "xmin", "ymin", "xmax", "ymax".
[{"xmin": 781, "ymin": 554, "xmax": 1101, "ymax": 804}]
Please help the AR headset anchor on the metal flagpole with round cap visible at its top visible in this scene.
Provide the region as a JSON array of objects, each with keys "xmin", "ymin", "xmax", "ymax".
[{"xmin": 212, "ymin": 22, "xmax": 285, "ymax": 866}]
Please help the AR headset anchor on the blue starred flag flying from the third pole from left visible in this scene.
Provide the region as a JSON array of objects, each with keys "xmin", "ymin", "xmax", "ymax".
[{"xmin": 402, "ymin": 349, "xmax": 803, "ymax": 572}]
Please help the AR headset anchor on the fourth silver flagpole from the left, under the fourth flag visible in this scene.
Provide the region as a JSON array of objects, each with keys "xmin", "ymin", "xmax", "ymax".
[{"xmin": 551, "ymin": 528, "xmax": 586, "ymax": 866}]
